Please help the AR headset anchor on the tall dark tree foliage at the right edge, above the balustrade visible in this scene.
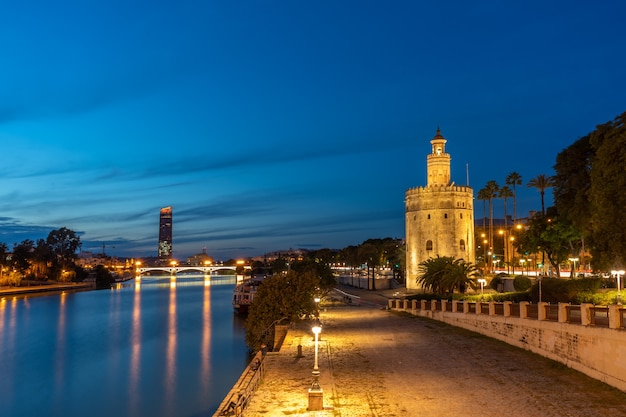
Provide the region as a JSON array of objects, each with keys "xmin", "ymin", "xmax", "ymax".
[{"xmin": 554, "ymin": 113, "xmax": 626, "ymax": 270}]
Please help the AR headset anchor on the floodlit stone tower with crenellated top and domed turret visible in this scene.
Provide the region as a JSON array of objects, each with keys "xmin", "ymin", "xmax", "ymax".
[{"xmin": 405, "ymin": 129, "xmax": 475, "ymax": 289}]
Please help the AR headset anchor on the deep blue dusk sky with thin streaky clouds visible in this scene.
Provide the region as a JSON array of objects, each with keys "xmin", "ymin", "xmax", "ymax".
[{"xmin": 0, "ymin": 0, "xmax": 626, "ymax": 260}]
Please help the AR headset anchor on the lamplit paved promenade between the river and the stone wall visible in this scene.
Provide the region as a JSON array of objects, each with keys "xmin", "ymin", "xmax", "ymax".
[{"xmin": 243, "ymin": 288, "xmax": 626, "ymax": 417}]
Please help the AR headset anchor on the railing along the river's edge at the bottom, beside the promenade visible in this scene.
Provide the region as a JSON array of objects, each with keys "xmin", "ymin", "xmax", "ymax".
[{"xmin": 213, "ymin": 352, "xmax": 265, "ymax": 417}]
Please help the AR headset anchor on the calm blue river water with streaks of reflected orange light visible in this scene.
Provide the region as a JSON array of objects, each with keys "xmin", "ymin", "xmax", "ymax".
[{"xmin": 0, "ymin": 275, "xmax": 248, "ymax": 417}]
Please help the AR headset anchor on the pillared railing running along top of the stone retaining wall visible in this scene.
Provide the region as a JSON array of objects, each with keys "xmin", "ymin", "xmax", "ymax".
[{"xmin": 389, "ymin": 299, "xmax": 626, "ymax": 330}]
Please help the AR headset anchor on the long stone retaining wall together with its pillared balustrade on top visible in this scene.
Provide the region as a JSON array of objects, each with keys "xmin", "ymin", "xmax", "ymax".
[{"xmin": 388, "ymin": 299, "xmax": 626, "ymax": 392}]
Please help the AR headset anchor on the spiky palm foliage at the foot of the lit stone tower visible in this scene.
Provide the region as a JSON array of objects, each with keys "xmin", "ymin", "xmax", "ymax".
[{"xmin": 417, "ymin": 256, "xmax": 478, "ymax": 295}]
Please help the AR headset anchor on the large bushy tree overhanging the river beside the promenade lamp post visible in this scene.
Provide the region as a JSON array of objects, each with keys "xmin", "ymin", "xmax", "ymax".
[{"xmin": 245, "ymin": 260, "xmax": 334, "ymax": 350}]
